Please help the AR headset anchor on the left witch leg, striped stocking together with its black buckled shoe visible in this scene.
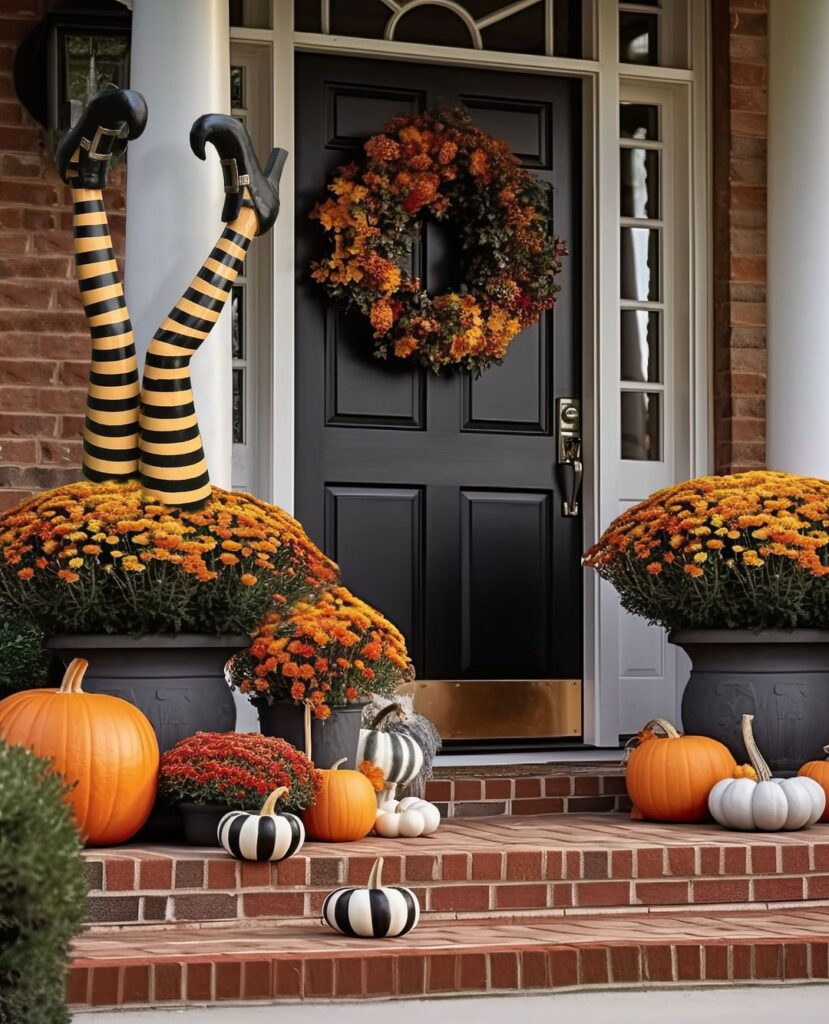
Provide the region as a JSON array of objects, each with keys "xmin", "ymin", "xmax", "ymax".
[{"xmin": 55, "ymin": 89, "xmax": 146, "ymax": 481}]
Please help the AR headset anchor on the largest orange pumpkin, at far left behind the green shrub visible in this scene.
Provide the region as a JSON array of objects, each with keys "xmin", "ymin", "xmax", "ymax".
[{"xmin": 0, "ymin": 657, "xmax": 159, "ymax": 852}]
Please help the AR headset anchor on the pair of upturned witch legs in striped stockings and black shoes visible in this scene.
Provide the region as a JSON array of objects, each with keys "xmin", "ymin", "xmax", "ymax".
[{"xmin": 56, "ymin": 89, "xmax": 288, "ymax": 508}]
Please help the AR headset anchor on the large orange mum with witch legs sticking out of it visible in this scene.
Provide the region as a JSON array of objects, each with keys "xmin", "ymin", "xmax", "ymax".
[{"xmin": 0, "ymin": 481, "xmax": 337, "ymax": 635}]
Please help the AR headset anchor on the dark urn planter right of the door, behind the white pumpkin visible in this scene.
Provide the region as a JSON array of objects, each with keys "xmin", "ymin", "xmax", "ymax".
[{"xmin": 668, "ymin": 630, "xmax": 829, "ymax": 775}]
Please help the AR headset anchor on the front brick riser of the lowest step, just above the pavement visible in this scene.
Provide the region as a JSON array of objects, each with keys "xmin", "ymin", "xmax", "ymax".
[{"xmin": 69, "ymin": 941, "xmax": 829, "ymax": 1010}]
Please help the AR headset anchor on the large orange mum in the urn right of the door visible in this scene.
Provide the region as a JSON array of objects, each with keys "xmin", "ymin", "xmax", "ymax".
[{"xmin": 584, "ymin": 471, "xmax": 829, "ymax": 630}]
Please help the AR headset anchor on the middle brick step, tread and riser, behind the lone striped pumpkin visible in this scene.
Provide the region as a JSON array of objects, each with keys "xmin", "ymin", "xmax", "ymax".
[{"xmin": 85, "ymin": 814, "xmax": 829, "ymax": 928}]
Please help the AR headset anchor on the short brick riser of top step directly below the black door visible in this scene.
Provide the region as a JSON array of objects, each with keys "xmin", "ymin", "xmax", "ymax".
[{"xmin": 426, "ymin": 754, "xmax": 630, "ymax": 818}]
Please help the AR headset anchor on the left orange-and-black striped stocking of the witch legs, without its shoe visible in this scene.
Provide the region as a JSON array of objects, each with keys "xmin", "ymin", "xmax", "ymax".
[{"xmin": 69, "ymin": 155, "xmax": 139, "ymax": 481}]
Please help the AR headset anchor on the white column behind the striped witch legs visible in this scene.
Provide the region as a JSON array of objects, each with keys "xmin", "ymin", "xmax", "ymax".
[{"xmin": 126, "ymin": 0, "xmax": 232, "ymax": 487}]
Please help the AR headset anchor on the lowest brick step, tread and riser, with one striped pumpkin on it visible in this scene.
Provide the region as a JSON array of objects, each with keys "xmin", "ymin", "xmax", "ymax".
[{"xmin": 69, "ymin": 907, "xmax": 829, "ymax": 1009}]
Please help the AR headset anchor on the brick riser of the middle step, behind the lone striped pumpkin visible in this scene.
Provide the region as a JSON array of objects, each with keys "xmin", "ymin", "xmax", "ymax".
[{"xmin": 82, "ymin": 844, "xmax": 829, "ymax": 926}]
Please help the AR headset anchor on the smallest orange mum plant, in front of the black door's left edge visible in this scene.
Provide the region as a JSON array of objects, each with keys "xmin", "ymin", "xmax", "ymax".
[{"xmin": 230, "ymin": 587, "xmax": 413, "ymax": 719}]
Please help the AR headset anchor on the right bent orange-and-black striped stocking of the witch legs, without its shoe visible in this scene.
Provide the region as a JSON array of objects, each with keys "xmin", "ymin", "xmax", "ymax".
[{"xmin": 140, "ymin": 201, "xmax": 258, "ymax": 507}]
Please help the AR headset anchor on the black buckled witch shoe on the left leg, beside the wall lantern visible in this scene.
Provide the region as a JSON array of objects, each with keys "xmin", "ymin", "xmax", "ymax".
[{"xmin": 54, "ymin": 89, "xmax": 146, "ymax": 188}]
